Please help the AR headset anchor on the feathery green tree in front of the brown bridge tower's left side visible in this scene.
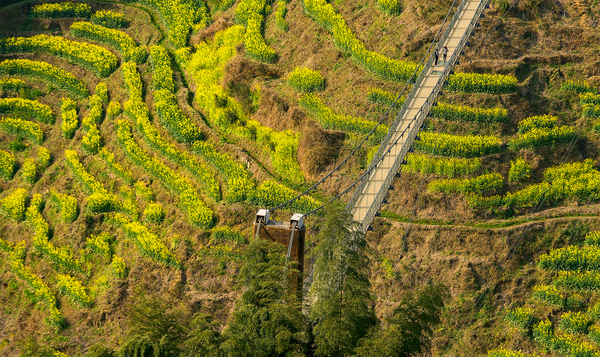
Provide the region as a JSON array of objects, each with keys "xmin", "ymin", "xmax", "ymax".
[{"xmin": 221, "ymin": 239, "xmax": 307, "ymax": 357}]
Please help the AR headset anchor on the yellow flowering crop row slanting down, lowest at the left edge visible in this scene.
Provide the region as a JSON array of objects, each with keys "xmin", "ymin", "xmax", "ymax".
[{"xmin": 9, "ymin": 242, "xmax": 64, "ymax": 327}]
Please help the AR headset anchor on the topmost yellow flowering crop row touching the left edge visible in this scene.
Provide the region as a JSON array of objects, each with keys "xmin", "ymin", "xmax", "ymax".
[{"xmin": 0, "ymin": 34, "xmax": 117, "ymax": 77}]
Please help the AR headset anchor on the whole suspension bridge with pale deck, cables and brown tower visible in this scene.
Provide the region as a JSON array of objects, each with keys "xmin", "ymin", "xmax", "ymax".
[{"xmin": 254, "ymin": 0, "xmax": 490, "ymax": 280}]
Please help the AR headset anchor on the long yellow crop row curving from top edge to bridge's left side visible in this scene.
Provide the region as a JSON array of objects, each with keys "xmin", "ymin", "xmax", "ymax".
[{"xmin": 303, "ymin": 0, "xmax": 418, "ymax": 81}]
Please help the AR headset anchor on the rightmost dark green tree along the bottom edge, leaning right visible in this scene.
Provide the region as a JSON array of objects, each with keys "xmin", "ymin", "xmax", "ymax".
[{"xmin": 356, "ymin": 285, "xmax": 447, "ymax": 357}]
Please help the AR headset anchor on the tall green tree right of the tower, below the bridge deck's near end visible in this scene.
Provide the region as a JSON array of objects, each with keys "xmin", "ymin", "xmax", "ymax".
[{"xmin": 309, "ymin": 205, "xmax": 377, "ymax": 356}]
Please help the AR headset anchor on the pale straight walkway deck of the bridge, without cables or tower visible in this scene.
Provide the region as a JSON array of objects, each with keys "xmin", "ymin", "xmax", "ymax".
[{"xmin": 347, "ymin": 0, "xmax": 489, "ymax": 232}]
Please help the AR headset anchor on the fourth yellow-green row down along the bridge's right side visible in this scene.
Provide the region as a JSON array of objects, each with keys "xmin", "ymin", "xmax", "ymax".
[{"xmin": 402, "ymin": 154, "xmax": 481, "ymax": 177}]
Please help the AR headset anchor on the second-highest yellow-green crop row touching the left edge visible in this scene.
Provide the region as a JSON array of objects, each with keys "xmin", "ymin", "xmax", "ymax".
[{"xmin": 0, "ymin": 59, "xmax": 89, "ymax": 98}]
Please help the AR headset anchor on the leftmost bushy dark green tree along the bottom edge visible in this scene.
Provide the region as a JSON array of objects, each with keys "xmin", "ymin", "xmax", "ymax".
[{"xmin": 118, "ymin": 296, "xmax": 188, "ymax": 357}]
